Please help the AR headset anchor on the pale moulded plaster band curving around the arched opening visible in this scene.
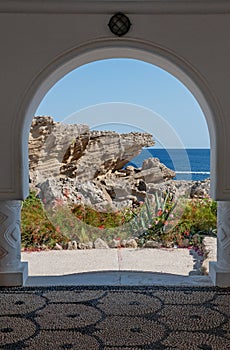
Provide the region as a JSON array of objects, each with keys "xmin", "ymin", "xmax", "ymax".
[{"xmin": 13, "ymin": 39, "xmax": 222, "ymax": 200}]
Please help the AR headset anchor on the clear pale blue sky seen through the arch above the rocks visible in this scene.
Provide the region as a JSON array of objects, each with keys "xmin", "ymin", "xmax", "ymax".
[{"xmin": 36, "ymin": 59, "xmax": 209, "ymax": 148}]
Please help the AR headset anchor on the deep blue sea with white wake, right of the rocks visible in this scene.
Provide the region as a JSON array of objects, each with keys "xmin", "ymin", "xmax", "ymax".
[{"xmin": 129, "ymin": 148, "xmax": 210, "ymax": 180}]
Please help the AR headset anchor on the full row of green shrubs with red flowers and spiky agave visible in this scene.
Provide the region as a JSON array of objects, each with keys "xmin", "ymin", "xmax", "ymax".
[{"xmin": 21, "ymin": 192, "xmax": 217, "ymax": 249}]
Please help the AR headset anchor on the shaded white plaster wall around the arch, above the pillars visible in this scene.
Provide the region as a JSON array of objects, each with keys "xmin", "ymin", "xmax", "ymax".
[{"xmin": 0, "ymin": 0, "xmax": 230, "ymax": 200}]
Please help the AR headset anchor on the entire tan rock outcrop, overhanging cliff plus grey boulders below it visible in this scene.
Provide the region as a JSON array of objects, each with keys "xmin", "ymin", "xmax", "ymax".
[{"xmin": 29, "ymin": 117, "xmax": 178, "ymax": 208}]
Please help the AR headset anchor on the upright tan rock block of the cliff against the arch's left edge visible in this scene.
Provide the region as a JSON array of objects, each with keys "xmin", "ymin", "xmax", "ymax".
[{"xmin": 29, "ymin": 117, "xmax": 89, "ymax": 185}]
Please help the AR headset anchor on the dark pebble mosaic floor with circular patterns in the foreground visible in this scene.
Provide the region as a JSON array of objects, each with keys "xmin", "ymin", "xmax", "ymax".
[{"xmin": 0, "ymin": 287, "xmax": 230, "ymax": 350}]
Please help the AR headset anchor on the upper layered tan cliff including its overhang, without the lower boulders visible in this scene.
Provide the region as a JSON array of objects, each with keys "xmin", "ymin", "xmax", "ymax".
[{"xmin": 29, "ymin": 117, "xmax": 154, "ymax": 182}]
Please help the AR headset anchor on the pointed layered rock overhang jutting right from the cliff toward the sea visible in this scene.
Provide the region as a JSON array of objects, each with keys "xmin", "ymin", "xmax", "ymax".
[{"xmin": 61, "ymin": 131, "xmax": 154, "ymax": 182}]
